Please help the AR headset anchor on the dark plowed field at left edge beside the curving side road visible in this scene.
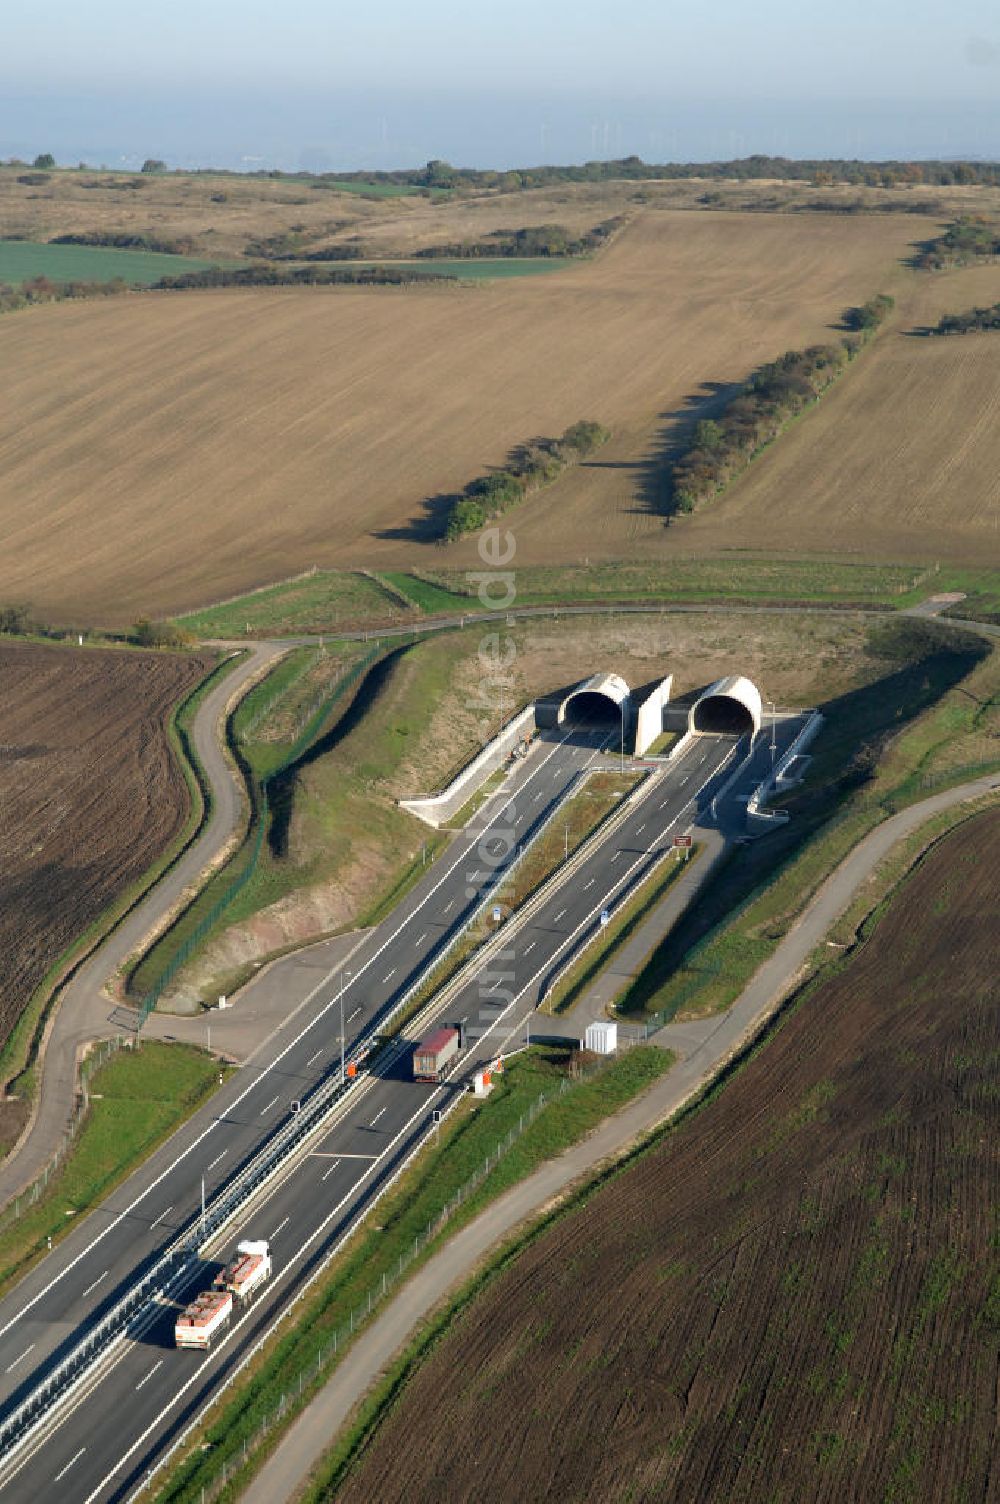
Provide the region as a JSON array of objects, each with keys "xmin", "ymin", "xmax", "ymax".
[{"xmin": 0, "ymin": 644, "xmax": 209, "ymax": 1064}]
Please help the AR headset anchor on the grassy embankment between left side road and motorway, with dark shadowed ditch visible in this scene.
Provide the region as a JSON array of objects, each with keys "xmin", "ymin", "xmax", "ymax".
[{"xmin": 129, "ymin": 638, "xmax": 475, "ymax": 996}]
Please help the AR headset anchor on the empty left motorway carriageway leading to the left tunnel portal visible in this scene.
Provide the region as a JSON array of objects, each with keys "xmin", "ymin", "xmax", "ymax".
[{"xmin": 0, "ymin": 731, "xmax": 605, "ymax": 1408}]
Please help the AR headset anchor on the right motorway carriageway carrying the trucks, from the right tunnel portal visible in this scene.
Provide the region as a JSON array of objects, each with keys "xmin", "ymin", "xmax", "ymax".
[{"xmin": 5, "ymin": 726, "xmax": 797, "ymax": 1498}]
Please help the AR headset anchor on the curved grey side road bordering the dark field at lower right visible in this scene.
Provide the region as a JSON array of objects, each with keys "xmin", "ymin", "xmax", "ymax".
[{"xmin": 242, "ymin": 775, "xmax": 1000, "ymax": 1504}]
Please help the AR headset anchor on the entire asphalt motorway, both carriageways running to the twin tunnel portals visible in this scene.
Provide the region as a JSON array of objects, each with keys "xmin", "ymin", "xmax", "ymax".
[{"xmin": 0, "ymin": 720, "xmax": 800, "ymax": 1501}]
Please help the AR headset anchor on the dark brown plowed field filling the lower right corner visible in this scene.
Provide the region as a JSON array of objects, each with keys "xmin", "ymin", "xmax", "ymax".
[{"xmin": 337, "ymin": 811, "xmax": 1000, "ymax": 1504}]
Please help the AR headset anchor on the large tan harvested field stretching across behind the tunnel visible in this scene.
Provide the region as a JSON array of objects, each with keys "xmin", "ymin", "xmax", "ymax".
[{"xmin": 0, "ymin": 211, "xmax": 919, "ymax": 623}]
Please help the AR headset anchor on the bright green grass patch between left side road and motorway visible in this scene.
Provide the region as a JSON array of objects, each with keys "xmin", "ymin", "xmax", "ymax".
[{"xmin": 0, "ymin": 1041, "xmax": 220, "ymax": 1293}]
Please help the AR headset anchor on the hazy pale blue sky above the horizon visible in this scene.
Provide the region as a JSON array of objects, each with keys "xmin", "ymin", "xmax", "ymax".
[{"xmin": 0, "ymin": 0, "xmax": 1000, "ymax": 171}]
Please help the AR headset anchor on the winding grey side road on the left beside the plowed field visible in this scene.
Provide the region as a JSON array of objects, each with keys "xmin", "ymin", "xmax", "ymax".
[{"xmin": 0, "ymin": 642, "xmax": 287, "ymax": 1206}]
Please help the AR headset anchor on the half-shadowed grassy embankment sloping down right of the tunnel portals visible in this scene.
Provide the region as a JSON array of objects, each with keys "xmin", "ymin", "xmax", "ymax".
[{"xmin": 618, "ymin": 621, "xmax": 1000, "ymax": 1018}]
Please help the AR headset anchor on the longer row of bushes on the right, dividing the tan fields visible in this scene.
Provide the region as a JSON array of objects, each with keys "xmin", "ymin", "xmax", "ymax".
[{"xmin": 671, "ymin": 293, "xmax": 893, "ymax": 513}]
